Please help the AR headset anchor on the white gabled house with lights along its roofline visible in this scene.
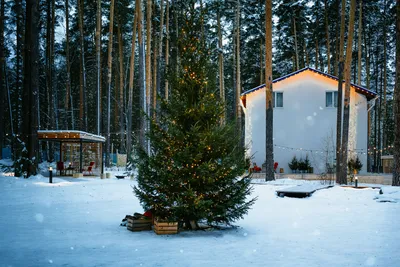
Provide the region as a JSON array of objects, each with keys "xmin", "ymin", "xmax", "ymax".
[{"xmin": 241, "ymin": 68, "xmax": 377, "ymax": 173}]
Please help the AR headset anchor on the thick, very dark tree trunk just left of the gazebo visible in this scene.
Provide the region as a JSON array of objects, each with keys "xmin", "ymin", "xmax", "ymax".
[{"xmin": 21, "ymin": 0, "xmax": 39, "ymax": 177}]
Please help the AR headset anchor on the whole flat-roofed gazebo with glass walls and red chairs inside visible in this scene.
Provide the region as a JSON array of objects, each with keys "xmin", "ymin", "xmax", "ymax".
[{"xmin": 38, "ymin": 130, "xmax": 106, "ymax": 176}]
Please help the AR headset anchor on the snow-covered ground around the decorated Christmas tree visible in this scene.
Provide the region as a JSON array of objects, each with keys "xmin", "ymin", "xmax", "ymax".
[{"xmin": 0, "ymin": 176, "xmax": 400, "ymax": 266}]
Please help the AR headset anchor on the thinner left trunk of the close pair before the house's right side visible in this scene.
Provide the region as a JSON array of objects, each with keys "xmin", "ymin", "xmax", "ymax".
[{"xmin": 336, "ymin": 0, "xmax": 346, "ymax": 184}]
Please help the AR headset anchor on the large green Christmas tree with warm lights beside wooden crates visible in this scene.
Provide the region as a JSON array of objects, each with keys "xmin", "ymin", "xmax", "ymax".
[{"xmin": 134, "ymin": 5, "xmax": 255, "ymax": 228}]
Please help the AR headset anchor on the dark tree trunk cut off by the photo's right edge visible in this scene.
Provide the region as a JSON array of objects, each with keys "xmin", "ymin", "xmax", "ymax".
[{"xmin": 392, "ymin": 0, "xmax": 400, "ymax": 186}]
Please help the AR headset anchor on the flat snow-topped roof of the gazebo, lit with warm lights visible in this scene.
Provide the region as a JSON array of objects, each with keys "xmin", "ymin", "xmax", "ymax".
[{"xmin": 38, "ymin": 130, "xmax": 106, "ymax": 143}]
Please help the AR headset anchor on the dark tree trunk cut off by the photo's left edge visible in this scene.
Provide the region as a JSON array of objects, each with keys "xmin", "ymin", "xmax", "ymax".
[{"xmin": 0, "ymin": 0, "xmax": 4, "ymax": 159}]
